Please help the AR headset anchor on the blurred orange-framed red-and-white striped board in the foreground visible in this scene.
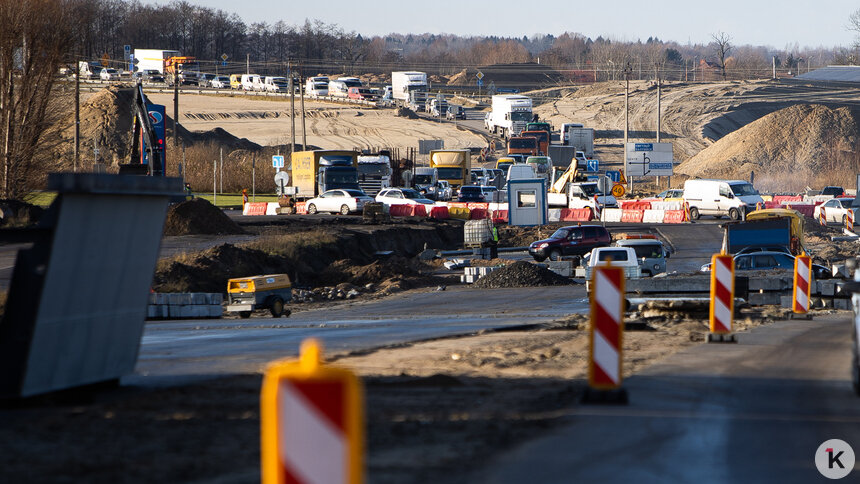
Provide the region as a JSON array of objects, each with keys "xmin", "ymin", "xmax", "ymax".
[{"xmin": 260, "ymin": 339, "xmax": 364, "ymax": 484}]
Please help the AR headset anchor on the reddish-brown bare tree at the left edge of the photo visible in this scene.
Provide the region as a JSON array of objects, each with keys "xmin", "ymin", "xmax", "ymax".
[{"xmin": 0, "ymin": 0, "xmax": 71, "ymax": 199}]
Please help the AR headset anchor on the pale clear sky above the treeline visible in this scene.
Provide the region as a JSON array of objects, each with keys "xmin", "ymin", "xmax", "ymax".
[{"xmin": 160, "ymin": 0, "xmax": 860, "ymax": 49}]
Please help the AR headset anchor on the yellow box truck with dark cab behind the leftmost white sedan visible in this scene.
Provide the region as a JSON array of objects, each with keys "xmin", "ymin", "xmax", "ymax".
[{"xmin": 290, "ymin": 150, "xmax": 361, "ymax": 200}]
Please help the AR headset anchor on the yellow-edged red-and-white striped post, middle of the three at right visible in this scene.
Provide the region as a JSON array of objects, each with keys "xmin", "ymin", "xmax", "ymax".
[{"xmin": 708, "ymin": 253, "xmax": 737, "ymax": 343}]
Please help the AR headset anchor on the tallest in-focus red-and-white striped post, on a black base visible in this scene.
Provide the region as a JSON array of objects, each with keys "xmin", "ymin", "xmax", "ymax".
[{"xmin": 583, "ymin": 263, "xmax": 627, "ymax": 403}]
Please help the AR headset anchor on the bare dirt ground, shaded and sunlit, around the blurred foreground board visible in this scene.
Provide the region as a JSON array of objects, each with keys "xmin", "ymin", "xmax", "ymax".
[{"xmin": 0, "ymin": 300, "xmax": 800, "ymax": 483}]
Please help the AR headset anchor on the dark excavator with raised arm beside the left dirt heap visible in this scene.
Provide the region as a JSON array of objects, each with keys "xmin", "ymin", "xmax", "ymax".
[{"xmin": 119, "ymin": 81, "xmax": 165, "ymax": 176}]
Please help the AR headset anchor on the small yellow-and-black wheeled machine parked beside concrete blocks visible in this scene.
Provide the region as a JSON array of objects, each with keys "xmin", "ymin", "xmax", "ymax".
[{"xmin": 227, "ymin": 274, "xmax": 293, "ymax": 318}]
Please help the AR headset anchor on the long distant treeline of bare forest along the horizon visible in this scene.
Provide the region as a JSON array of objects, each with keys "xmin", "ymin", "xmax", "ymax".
[{"xmin": 67, "ymin": 0, "xmax": 856, "ymax": 80}]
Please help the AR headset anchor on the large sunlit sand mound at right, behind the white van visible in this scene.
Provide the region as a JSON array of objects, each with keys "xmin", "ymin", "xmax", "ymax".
[{"xmin": 677, "ymin": 104, "xmax": 858, "ymax": 190}]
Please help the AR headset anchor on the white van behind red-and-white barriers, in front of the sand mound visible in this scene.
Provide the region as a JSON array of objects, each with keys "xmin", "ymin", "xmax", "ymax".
[{"xmin": 684, "ymin": 180, "xmax": 764, "ymax": 220}]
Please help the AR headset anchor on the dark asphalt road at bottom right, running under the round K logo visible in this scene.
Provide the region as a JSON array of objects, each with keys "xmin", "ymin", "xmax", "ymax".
[{"xmin": 479, "ymin": 313, "xmax": 860, "ymax": 484}]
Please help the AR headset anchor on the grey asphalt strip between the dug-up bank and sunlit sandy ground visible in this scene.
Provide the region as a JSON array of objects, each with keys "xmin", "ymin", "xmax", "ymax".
[{"xmin": 129, "ymin": 285, "xmax": 588, "ymax": 383}]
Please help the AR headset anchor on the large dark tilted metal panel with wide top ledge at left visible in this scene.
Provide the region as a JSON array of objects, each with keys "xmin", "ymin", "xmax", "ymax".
[{"xmin": 0, "ymin": 174, "xmax": 182, "ymax": 398}]
